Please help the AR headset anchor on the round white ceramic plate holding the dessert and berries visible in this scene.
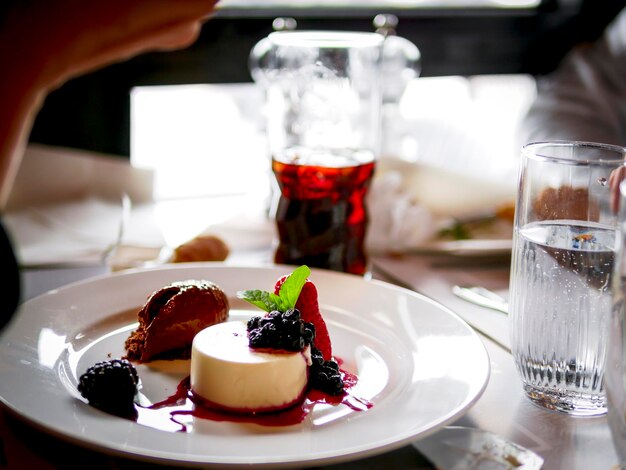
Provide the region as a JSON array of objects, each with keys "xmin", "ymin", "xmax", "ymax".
[{"xmin": 0, "ymin": 263, "xmax": 489, "ymax": 467}]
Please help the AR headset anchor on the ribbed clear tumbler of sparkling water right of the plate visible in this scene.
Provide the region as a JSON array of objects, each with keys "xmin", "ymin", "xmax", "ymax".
[{"xmin": 509, "ymin": 142, "xmax": 625, "ymax": 416}]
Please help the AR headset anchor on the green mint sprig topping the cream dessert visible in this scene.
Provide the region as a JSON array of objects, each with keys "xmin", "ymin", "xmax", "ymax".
[{"xmin": 237, "ymin": 266, "xmax": 311, "ymax": 312}]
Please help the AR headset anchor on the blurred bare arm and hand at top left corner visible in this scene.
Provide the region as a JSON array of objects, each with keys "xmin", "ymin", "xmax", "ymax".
[{"xmin": 0, "ymin": 0, "xmax": 217, "ymax": 210}]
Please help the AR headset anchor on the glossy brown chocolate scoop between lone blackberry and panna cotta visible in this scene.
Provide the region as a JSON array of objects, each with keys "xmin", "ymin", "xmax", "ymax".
[{"xmin": 125, "ymin": 280, "xmax": 229, "ymax": 362}]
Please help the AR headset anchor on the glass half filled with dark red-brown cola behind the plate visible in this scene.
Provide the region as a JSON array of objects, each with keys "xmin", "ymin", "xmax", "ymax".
[{"xmin": 246, "ymin": 31, "xmax": 384, "ymax": 275}]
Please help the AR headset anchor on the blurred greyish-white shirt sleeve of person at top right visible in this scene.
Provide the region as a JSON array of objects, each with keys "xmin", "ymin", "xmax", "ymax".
[{"xmin": 520, "ymin": 8, "xmax": 626, "ymax": 146}]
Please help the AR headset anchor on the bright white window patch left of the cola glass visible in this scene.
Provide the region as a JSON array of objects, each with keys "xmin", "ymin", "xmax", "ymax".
[{"xmin": 131, "ymin": 85, "xmax": 269, "ymax": 200}]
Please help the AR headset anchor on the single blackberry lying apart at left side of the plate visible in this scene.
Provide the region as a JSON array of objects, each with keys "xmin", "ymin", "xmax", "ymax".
[{"xmin": 78, "ymin": 359, "xmax": 139, "ymax": 416}]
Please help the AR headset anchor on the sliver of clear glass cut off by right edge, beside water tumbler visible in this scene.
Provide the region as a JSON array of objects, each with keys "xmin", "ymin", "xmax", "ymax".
[{"xmin": 604, "ymin": 177, "xmax": 626, "ymax": 469}]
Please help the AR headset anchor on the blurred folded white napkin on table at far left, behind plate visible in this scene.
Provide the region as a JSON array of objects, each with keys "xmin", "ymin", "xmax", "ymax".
[{"xmin": 3, "ymin": 144, "xmax": 163, "ymax": 267}]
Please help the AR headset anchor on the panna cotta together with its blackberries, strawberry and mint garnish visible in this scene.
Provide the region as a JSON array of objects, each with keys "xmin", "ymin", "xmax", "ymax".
[{"xmin": 190, "ymin": 266, "xmax": 344, "ymax": 413}]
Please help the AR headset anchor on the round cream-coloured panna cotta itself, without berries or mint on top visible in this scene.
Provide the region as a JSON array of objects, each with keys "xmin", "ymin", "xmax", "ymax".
[{"xmin": 190, "ymin": 321, "xmax": 311, "ymax": 413}]
